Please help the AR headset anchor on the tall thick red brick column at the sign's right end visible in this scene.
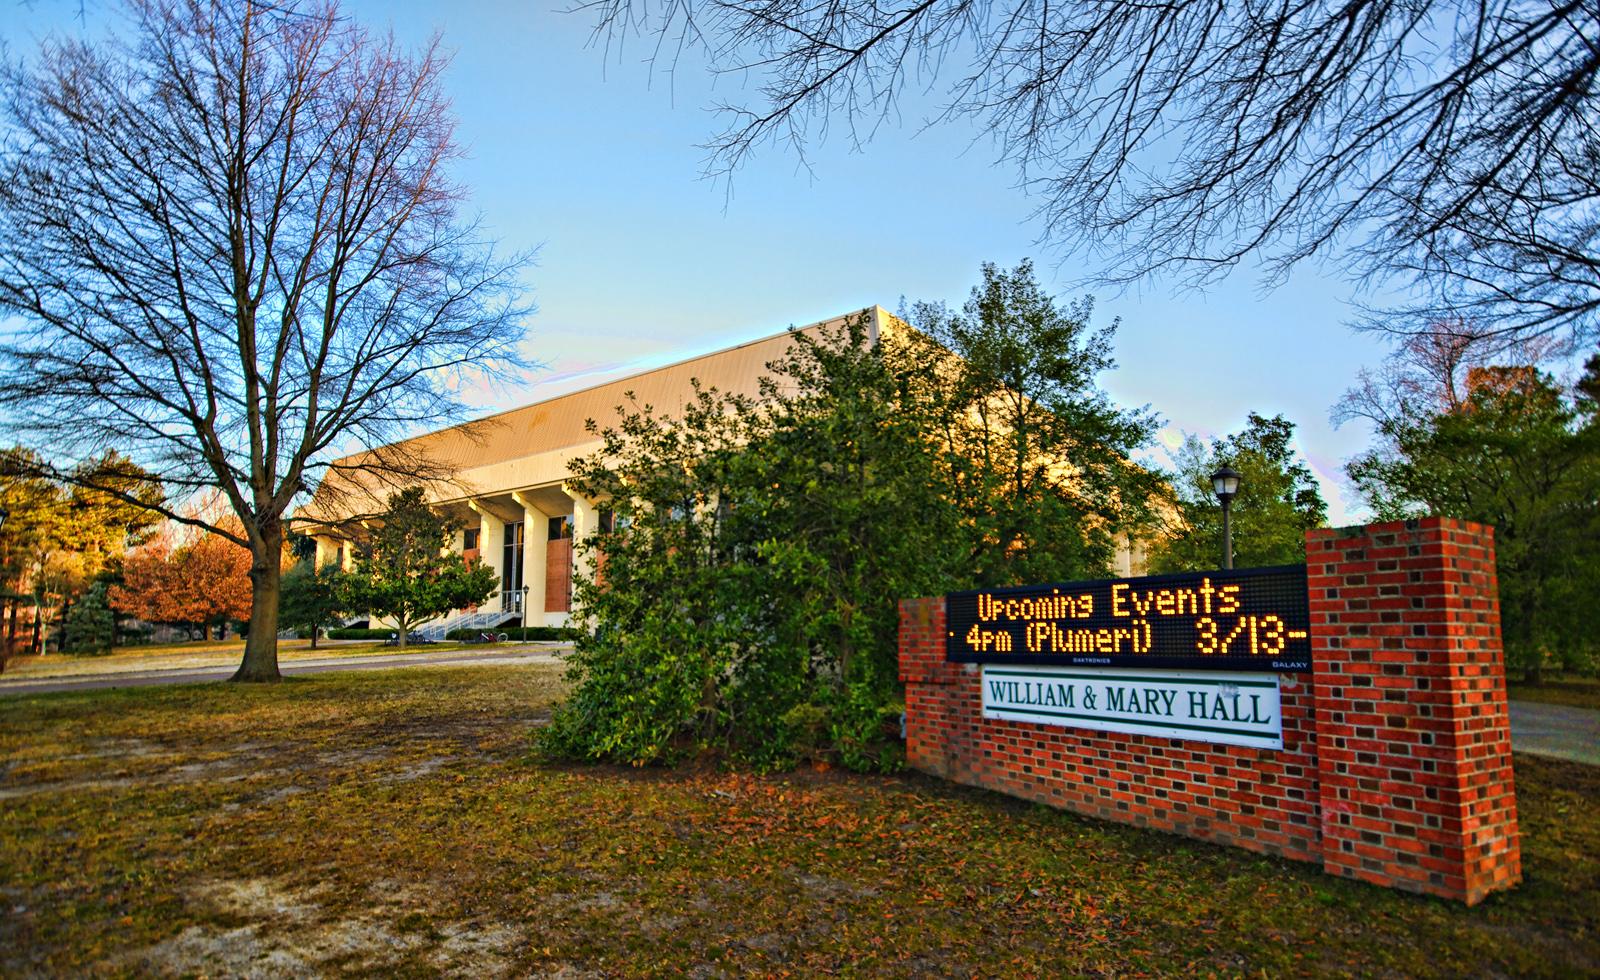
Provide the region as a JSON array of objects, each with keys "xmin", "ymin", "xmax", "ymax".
[{"xmin": 1306, "ymin": 517, "xmax": 1522, "ymax": 905}]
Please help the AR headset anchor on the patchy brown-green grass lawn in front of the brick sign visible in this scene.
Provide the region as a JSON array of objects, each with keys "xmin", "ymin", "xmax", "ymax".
[{"xmin": 0, "ymin": 665, "xmax": 1600, "ymax": 977}]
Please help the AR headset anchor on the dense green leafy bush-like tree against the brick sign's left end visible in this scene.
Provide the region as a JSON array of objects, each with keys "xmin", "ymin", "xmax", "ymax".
[{"xmin": 544, "ymin": 320, "xmax": 963, "ymax": 769}]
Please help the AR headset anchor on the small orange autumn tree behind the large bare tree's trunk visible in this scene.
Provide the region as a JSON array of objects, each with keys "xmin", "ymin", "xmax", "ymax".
[{"xmin": 109, "ymin": 528, "xmax": 251, "ymax": 639}]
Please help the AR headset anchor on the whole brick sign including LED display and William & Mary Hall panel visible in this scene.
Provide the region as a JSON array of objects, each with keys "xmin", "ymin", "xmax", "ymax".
[{"xmin": 899, "ymin": 517, "xmax": 1522, "ymax": 903}]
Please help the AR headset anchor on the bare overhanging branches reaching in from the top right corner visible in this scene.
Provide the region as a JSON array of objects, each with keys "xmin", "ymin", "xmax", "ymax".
[{"xmin": 579, "ymin": 0, "xmax": 1600, "ymax": 350}]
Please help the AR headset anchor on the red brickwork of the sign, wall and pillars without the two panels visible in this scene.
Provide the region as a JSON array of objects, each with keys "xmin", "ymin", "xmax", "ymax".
[{"xmin": 899, "ymin": 519, "xmax": 1522, "ymax": 905}]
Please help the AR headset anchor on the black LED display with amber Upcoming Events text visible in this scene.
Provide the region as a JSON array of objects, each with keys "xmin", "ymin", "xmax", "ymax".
[{"xmin": 946, "ymin": 565, "xmax": 1310, "ymax": 673}]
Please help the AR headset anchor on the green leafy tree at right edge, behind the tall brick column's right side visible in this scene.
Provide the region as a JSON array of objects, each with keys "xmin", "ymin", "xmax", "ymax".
[{"xmin": 1349, "ymin": 357, "xmax": 1600, "ymax": 681}]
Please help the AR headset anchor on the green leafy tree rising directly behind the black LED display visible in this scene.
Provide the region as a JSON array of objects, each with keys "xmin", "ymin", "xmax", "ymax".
[{"xmin": 906, "ymin": 261, "xmax": 1158, "ymax": 584}]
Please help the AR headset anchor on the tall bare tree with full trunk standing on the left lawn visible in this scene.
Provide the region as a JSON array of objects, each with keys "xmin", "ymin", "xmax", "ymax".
[{"xmin": 0, "ymin": 0, "xmax": 537, "ymax": 681}]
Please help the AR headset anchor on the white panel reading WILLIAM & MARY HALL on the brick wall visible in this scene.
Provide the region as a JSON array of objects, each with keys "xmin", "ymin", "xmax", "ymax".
[{"xmin": 982, "ymin": 665, "xmax": 1283, "ymax": 748}]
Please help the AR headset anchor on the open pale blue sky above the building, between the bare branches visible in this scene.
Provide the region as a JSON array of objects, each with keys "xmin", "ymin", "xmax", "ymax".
[{"xmin": 0, "ymin": 0, "xmax": 1384, "ymax": 522}]
